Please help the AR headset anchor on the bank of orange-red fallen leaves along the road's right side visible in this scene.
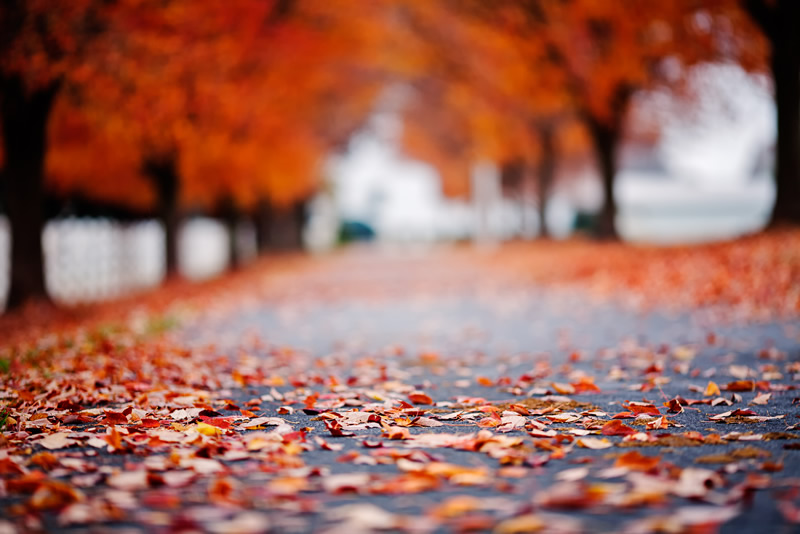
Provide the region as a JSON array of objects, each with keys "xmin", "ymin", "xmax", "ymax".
[{"xmin": 487, "ymin": 230, "xmax": 800, "ymax": 320}]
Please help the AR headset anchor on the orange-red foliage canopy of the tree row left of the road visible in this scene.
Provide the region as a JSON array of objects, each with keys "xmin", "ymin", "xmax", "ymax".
[{"xmin": 3, "ymin": 0, "xmax": 384, "ymax": 214}]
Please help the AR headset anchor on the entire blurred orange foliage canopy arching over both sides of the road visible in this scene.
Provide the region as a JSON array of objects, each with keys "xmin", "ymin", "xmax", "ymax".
[{"xmin": 0, "ymin": 0, "xmax": 766, "ymax": 213}]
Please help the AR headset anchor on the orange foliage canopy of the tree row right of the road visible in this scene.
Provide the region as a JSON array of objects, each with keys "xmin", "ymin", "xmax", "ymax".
[{"xmin": 394, "ymin": 0, "xmax": 767, "ymax": 201}]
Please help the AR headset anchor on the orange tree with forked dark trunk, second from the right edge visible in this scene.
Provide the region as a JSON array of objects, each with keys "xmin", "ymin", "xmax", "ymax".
[{"xmin": 524, "ymin": 0, "xmax": 759, "ymax": 238}]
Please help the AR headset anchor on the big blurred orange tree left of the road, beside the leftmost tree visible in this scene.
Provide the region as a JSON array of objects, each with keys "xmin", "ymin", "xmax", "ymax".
[{"xmin": 42, "ymin": 0, "xmax": 375, "ymax": 282}]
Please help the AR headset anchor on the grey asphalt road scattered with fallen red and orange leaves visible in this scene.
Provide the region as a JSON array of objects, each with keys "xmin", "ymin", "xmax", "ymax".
[{"xmin": 0, "ymin": 251, "xmax": 800, "ymax": 534}]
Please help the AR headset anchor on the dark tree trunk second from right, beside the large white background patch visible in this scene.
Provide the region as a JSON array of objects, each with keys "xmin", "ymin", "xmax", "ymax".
[{"xmin": 586, "ymin": 117, "xmax": 620, "ymax": 244}]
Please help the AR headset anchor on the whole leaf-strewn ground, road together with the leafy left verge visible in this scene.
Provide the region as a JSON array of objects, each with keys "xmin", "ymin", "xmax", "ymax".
[{"xmin": 0, "ymin": 243, "xmax": 800, "ymax": 534}]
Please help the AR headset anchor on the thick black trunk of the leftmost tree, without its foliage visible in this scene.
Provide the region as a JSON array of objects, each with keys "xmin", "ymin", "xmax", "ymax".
[{"xmin": 0, "ymin": 76, "xmax": 61, "ymax": 310}]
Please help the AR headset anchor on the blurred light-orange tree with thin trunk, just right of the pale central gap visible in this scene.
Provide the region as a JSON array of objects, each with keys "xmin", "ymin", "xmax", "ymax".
[{"xmin": 396, "ymin": 1, "xmax": 573, "ymax": 237}]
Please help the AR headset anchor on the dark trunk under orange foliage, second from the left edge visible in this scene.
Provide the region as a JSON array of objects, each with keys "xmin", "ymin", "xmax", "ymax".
[{"xmin": 144, "ymin": 154, "xmax": 181, "ymax": 278}]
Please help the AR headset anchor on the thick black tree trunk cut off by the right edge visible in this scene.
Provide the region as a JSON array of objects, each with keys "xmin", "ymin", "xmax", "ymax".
[{"xmin": 745, "ymin": 0, "xmax": 800, "ymax": 226}]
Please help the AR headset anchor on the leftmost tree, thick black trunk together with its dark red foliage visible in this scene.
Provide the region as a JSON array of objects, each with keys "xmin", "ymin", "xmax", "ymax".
[{"xmin": 0, "ymin": 0, "xmax": 119, "ymax": 308}]
